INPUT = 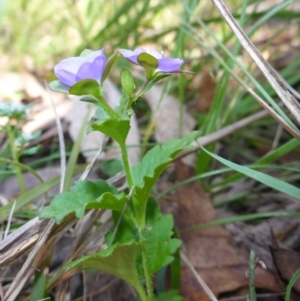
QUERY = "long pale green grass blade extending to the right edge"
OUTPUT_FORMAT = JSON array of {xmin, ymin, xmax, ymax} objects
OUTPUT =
[{"xmin": 201, "ymin": 146, "xmax": 300, "ymax": 200}]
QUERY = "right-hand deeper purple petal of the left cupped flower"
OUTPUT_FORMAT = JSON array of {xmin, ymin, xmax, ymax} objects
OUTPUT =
[{"xmin": 76, "ymin": 51, "xmax": 106, "ymax": 82}]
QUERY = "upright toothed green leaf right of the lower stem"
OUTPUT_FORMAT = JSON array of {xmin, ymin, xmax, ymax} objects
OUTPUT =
[{"xmin": 145, "ymin": 198, "xmax": 181, "ymax": 275}]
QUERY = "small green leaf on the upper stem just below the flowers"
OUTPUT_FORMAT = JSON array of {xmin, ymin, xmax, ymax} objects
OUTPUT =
[{"xmin": 90, "ymin": 107, "xmax": 130, "ymax": 145}]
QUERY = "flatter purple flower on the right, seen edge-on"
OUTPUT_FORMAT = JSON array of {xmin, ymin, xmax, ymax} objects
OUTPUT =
[{"xmin": 119, "ymin": 48, "xmax": 184, "ymax": 73}]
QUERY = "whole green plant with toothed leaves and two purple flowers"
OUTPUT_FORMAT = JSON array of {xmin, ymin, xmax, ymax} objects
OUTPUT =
[{"xmin": 41, "ymin": 48, "xmax": 197, "ymax": 301}]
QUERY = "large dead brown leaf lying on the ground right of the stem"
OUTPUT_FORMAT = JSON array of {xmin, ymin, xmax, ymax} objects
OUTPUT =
[{"xmin": 166, "ymin": 162, "xmax": 282, "ymax": 301}]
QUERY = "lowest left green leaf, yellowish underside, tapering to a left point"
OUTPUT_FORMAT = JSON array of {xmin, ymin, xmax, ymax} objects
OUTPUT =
[{"xmin": 65, "ymin": 242, "xmax": 144, "ymax": 294}]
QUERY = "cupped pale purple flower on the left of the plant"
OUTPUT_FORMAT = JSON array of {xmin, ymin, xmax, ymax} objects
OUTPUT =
[{"xmin": 54, "ymin": 49, "xmax": 106, "ymax": 87}]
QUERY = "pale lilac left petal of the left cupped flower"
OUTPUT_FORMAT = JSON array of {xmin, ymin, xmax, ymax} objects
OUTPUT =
[{"xmin": 54, "ymin": 57, "xmax": 85, "ymax": 87}]
